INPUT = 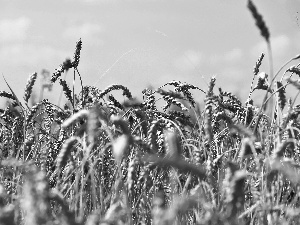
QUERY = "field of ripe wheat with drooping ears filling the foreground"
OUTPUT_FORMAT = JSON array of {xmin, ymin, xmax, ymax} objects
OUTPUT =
[{"xmin": 0, "ymin": 0, "xmax": 300, "ymax": 225}]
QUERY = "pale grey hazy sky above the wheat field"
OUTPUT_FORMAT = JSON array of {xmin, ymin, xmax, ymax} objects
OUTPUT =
[{"xmin": 0, "ymin": 0, "xmax": 300, "ymax": 107}]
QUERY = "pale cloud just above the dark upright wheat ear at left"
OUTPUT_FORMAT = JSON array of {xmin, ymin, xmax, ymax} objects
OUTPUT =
[{"xmin": 63, "ymin": 23, "xmax": 103, "ymax": 46}]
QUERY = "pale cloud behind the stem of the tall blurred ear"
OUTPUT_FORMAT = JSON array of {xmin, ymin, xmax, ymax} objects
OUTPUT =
[{"xmin": 251, "ymin": 35, "xmax": 291, "ymax": 57}]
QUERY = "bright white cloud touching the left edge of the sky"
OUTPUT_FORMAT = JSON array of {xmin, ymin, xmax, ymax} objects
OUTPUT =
[{"xmin": 0, "ymin": 17, "xmax": 31, "ymax": 42}]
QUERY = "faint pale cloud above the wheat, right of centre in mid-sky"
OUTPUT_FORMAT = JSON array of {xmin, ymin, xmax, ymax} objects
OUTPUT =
[{"xmin": 174, "ymin": 50, "xmax": 204, "ymax": 72}]
